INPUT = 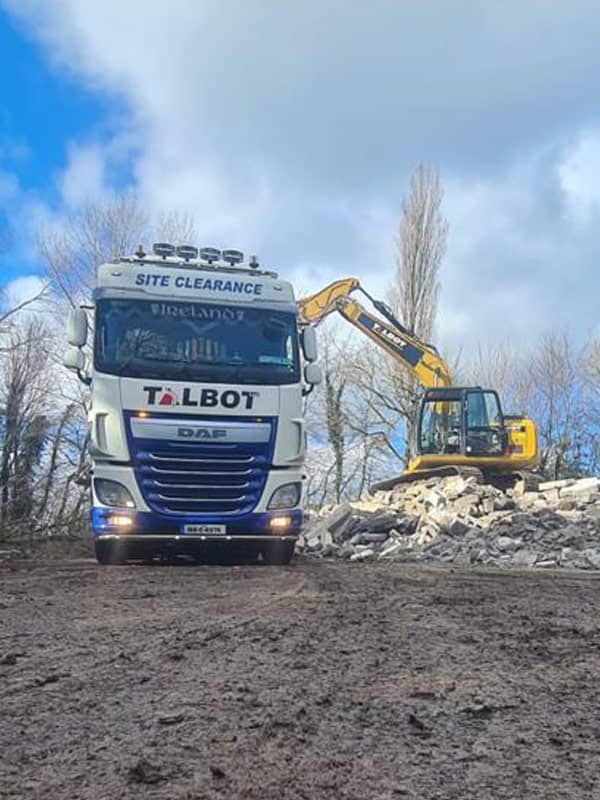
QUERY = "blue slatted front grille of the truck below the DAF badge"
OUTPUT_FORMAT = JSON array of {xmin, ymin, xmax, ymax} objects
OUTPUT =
[{"xmin": 129, "ymin": 416, "xmax": 274, "ymax": 516}]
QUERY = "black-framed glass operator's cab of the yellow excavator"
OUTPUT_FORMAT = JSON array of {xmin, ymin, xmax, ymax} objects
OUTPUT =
[{"xmin": 417, "ymin": 386, "xmax": 508, "ymax": 460}]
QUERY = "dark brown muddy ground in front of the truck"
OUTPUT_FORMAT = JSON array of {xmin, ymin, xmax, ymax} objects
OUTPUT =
[{"xmin": 0, "ymin": 559, "xmax": 600, "ymax": 800}]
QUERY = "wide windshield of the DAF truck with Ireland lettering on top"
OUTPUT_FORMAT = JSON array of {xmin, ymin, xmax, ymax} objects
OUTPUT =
[{"xmin": 94, "ymin": 299, "xmax": 300, "ymax": 384}]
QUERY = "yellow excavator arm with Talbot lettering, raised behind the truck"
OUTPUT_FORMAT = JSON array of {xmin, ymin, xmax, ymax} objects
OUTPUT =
[{"xmin": 298, "ymin": 278, "xmax": 452, "ymax": 388}]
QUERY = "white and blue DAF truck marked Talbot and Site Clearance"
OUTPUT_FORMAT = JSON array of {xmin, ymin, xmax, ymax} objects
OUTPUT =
[{"xmin": 64, "ymin": 242, "xmax": 321, "ymax": 564}]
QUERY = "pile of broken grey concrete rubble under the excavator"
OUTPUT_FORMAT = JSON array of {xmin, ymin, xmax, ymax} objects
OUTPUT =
[{"xmin": 299, "ymin": 475, "xmax": 600, "ymax": 569}]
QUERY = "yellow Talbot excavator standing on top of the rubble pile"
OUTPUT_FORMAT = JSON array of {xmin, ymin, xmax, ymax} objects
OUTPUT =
[{"xmin": 298, "ymin": 278, "xmax": 538, "ymax": 491}]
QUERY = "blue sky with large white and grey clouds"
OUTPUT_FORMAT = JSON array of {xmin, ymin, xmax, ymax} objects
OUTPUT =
[{"xmin": 0, "ymin": 0, "xmax": 600, "ymax": 351}]
